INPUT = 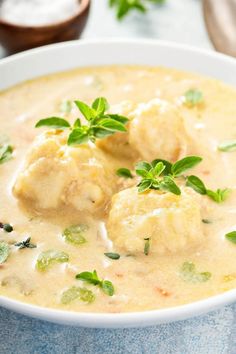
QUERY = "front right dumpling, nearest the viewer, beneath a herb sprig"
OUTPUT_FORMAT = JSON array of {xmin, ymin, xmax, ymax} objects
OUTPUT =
[{"xmin": 107, "ymin": 187, "xmax": 204, "ymax": 254}]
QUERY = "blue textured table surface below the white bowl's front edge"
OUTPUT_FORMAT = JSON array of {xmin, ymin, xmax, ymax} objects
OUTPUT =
[{"xmin": 0, "ymin": 305, "xmax": 236, "ymax": 354}]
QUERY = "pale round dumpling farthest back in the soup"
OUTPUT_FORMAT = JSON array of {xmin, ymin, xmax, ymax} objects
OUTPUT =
[{"xmin": 129, "ymin": 98, "xmax": 187, "ymax": 161}]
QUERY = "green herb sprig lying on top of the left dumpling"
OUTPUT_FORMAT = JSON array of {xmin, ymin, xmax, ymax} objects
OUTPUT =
[{"xmin": 35, "ymin": 97, "xmax": 128, "ymax": 145}]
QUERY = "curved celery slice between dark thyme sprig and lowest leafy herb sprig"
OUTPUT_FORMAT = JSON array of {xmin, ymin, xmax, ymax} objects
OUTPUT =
[{"xmin": 36, "ymin": 250, "xmax": 69, "ymax": 271}]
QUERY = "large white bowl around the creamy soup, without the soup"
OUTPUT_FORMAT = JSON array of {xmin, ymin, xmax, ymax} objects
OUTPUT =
[{"xmin": 0, "ymin": 39, "xmax": 236, "ymax": 328}]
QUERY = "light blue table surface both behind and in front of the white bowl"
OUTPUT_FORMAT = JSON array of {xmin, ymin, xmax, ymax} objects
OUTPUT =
[{"xmin": 0, "ymin": 0, "xmax": 236, "ymax": 354}]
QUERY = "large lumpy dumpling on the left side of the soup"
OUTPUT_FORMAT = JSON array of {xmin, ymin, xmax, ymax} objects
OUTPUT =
[{"xmin": 13, "ymin": 131, "xmax": 116, "ymax": 213}]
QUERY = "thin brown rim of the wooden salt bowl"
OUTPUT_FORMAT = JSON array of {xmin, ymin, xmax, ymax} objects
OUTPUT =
[{"xmin": 0, "ymin": 0, "xmax": 91, "ymax": 32}]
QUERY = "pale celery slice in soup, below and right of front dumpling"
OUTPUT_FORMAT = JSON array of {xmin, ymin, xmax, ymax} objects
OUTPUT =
[{"xmin": 180, "ymin": 262, "xmax": 211, "ymax": 283}]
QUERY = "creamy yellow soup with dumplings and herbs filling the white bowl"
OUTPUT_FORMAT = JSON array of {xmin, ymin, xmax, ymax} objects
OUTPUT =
[{"xmin": 0, "ymin": 66, "xmax": 236, "ymax": 313}]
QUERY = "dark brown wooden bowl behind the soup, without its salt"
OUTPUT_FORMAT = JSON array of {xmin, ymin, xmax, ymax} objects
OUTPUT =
[{"xmin": 0, "ymin": 0, "xmax": 91, "ymax": 54}]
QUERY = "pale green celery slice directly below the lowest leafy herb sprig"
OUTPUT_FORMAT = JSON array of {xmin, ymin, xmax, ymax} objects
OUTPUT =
[{"xmin": 61, "ymin": 286, "xmax": 95, "ymax": 305}]
